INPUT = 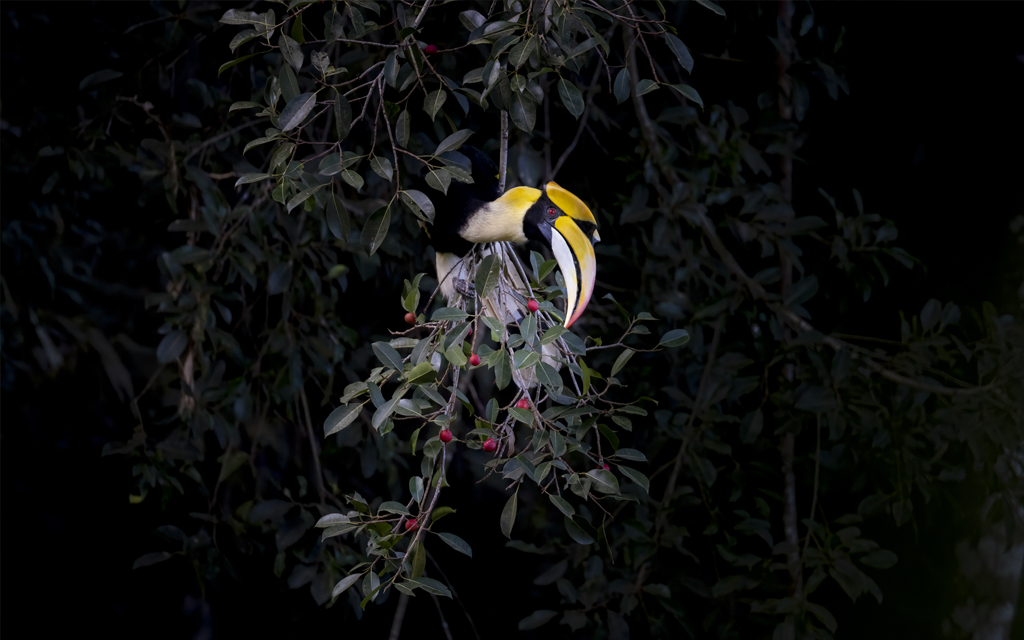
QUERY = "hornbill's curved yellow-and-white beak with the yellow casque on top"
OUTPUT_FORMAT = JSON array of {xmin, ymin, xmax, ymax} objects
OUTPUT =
[{"xmin": 545, "ymin": 182, "xmax": 601, "ymax": 329}]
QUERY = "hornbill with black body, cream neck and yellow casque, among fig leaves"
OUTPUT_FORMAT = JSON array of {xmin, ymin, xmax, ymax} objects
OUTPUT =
[{"xmin": 427, "ymin": 145, "xmax": 600, "ymax": 328}]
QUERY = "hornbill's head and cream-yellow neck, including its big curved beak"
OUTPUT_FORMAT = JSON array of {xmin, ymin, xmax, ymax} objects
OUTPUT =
[{"xmin": 446, "ymin": 182, "xmax": 600, "ymax": 327}]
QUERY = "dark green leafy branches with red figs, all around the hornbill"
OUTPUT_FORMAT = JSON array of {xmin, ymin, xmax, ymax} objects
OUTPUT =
[{"xmin": 2, "ymin": 0, "xmax": 1024, "ymax": 638}]
